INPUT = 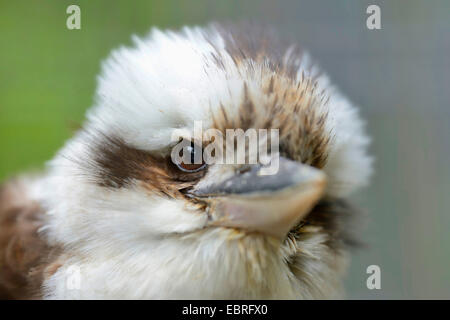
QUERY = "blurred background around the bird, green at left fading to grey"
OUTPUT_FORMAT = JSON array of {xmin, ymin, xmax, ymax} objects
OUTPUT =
[{"xmin": 0, "ymin": 0, "xmax": 450, "ymax": 299}]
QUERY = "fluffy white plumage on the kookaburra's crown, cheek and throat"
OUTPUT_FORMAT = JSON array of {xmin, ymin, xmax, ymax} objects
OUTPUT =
[{"xmin": 23, "ymin": 27, "xmax": 371, "ymax": 299}]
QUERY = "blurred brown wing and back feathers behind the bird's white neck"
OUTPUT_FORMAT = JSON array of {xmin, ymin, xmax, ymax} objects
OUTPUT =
[{"xmin": 0, "ymin": 180, "xmax": 59, "ymax": 299}]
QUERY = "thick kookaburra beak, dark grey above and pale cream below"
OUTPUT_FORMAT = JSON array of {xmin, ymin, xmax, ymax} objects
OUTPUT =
[{"xmin": 190, "ymin": 157, "xmax": 326, "ymax": 239}]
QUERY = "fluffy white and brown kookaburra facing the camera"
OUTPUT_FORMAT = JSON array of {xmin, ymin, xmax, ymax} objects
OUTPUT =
[{"xmin": 0, "ymin": 25, "xmax": 371, "ymax": 299}]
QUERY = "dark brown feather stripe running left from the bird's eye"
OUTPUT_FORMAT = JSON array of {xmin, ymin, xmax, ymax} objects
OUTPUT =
[{"xmin": 74, "ymin": 132, "xmax": 204, "ymax": 197}]
